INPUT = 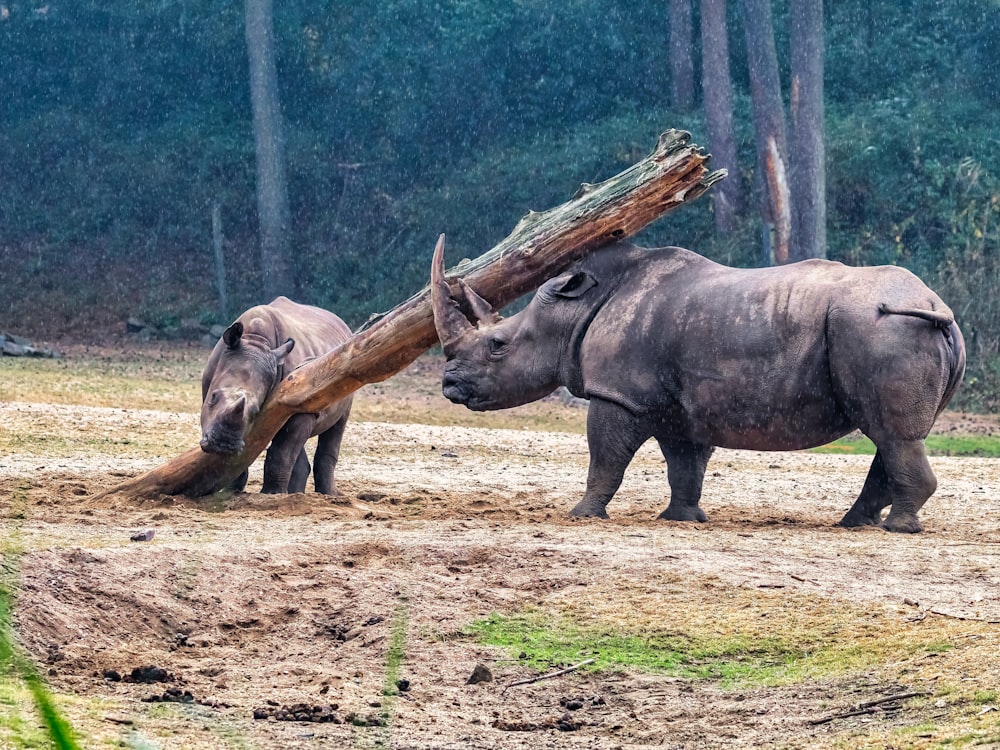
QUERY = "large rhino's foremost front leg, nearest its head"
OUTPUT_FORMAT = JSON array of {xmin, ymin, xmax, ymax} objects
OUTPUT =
[{"xmin": 569, "ymin": 398, "xmax": 650, "ymax": 518}]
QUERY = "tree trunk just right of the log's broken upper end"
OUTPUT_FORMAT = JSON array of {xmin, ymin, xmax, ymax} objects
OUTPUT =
[{"xmin": 701, "ymin": 0, "xmax": 743, "ymax": 234}]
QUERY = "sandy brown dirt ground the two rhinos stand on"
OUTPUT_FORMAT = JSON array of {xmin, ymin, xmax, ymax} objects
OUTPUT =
[{"xmin": 0, "ymin": 354, "xmax": 1000, "ymax": 750}]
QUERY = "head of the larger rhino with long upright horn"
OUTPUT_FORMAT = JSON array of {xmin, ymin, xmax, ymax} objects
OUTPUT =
[{"xmin": 431, "ymin": 235, "xmax": 596, "ymax": 411}]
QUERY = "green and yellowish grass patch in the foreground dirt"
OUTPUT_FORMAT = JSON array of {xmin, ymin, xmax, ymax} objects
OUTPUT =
[{"xmin": 466, "ymin": 589, "xmax": 968, "ymax": 688}]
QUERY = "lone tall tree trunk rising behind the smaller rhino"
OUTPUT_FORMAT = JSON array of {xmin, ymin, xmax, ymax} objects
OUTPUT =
[{"xmin": 246, "ymin": 0, "xmax": 294, "ymax": 300}]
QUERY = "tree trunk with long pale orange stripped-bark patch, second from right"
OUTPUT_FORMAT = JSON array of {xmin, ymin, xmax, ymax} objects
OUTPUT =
[{"xmin": 742, "ymin": 0, "xmax": 792, "ymax": 263}]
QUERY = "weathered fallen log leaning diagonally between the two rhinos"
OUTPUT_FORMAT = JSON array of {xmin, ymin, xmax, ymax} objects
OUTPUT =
[{"xmin": 104, "ymin": 130, "xmax": 726, "ymax": 497}]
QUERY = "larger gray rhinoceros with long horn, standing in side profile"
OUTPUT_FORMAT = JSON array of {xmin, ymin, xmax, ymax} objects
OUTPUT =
[{"xmin": 431, "ymin": 240, "xmax": 965, "ymax": 532}]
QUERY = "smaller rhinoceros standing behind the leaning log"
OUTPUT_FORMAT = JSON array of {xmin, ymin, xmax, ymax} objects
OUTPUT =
[{"xmin": 201, "ymin": 297, "xmax": 351, "ymax": 495}]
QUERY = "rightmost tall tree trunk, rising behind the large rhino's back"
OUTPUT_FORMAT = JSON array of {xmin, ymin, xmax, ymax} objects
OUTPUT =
[{"xmin": 790, "ymin": 0, "xmax": 826, "ymax": 260}]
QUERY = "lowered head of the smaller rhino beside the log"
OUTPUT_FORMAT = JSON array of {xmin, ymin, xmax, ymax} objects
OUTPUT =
[{"xmin": 201, "ymin": 321, "xmax": 295, "ymax": 454}]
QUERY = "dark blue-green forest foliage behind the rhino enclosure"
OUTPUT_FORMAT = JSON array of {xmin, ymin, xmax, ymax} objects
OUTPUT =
[{"xmin": 0, "ymin": 0, "xmax": 1000, "ymax": 411}]
